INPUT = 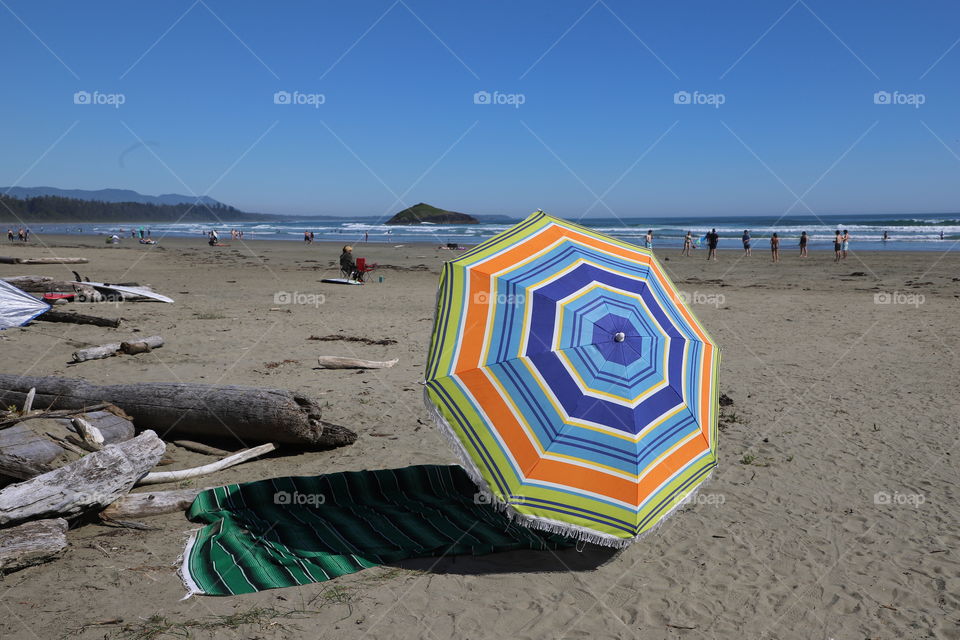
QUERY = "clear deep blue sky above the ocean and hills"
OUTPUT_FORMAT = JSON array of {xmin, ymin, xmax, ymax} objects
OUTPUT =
[{"xmin": 0, "ymin": 0, "xmax": 960, "ymax": 217}]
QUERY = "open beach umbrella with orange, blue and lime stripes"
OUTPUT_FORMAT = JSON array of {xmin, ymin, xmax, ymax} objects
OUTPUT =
[{"xmin": 425, "ymin": 211, "xmax": 720, "ymax": 546}]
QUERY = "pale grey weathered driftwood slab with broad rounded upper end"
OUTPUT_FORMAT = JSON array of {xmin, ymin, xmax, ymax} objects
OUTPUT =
[{"xmin": 0, "ymin": 430, "xmax": 166, "ymax": 527}]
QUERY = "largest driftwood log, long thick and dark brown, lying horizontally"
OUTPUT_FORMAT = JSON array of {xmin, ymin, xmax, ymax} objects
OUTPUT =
[{"xmin": 0, "ymin": 374, "xmax": 357, "ymax": 447}]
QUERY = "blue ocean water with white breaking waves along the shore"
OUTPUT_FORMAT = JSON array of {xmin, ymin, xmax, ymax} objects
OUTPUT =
[{"xmin": 35, "ymin": 213, "xmax": 960, "ymax": 251}]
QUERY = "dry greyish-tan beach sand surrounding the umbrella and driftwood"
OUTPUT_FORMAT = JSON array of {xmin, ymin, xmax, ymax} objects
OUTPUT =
[{"xmin": 0, "ymin": 237, "xmax": 960, "ymax": 640}]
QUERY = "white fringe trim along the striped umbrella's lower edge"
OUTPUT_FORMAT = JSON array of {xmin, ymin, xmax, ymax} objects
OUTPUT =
[{"xmin": 423, "ymin": 389, "xmax": 716, "ymax": 549}]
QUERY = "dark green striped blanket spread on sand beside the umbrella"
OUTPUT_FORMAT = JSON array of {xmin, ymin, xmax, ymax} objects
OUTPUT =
[{"xmin": 181, "ymin": 465, "xmax": 573, "ymax": 596}]
